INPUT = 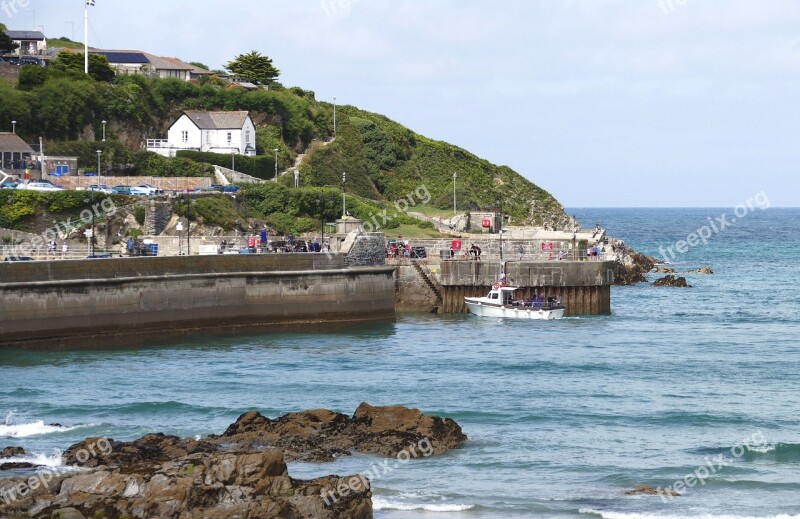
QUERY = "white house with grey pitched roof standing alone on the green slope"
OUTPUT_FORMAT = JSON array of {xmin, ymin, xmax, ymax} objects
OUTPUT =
[{"xmin": 147, "ymin": 111, "xmax": 256, "ymax": 157}]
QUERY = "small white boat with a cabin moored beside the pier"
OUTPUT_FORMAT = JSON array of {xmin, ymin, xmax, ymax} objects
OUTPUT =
[{"xmin": 464, "ymin": 286, "xmax": 564, "ymax": 320}]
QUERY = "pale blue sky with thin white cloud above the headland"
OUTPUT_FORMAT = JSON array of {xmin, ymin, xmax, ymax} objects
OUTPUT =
[{"xmin": 0, "ymin": 0, "xmax": 800, "ymax": 207}]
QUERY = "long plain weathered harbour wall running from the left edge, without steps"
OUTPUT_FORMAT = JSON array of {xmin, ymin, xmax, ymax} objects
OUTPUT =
[{"xmin": 0, "ymin": 254, "xmax": 395, "ymax": 349}]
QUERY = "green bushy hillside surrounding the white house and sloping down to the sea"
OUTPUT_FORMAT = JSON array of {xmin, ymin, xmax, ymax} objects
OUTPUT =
[{"xmin": 0, "ymin": 58, "xmax": 565, "ymax": 223}]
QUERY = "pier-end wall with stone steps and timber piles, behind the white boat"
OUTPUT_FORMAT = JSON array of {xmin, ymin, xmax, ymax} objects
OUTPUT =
[{"xmin": 395, "ymin": 260, "xmax": 614, "ymax": 316}]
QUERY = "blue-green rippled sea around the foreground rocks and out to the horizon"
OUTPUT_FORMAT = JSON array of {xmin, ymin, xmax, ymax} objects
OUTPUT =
[{"xmin": 0, "ymin": 208, "xmax": 800, "ymax": 519}]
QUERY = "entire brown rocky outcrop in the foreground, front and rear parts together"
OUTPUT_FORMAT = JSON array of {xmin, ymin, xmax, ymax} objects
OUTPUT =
[{"xmin": 0, "ymin": 404, "xmax": 467, "ymax": 519}]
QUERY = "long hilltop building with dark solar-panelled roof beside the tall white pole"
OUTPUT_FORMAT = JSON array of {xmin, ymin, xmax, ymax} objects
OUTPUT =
[{"xmin": 90, "ymin": 50, "xmax": 213, "ymax": 81}]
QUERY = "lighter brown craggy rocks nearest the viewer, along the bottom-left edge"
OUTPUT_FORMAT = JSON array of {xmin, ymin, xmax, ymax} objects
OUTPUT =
[{"xmin": 0, "ymin": 444, "xmax": 372, "ymax": 519}]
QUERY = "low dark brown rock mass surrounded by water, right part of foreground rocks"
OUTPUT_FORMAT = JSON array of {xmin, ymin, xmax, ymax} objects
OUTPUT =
[{"xmin": 219, "ymin": 403, "xmax": 467, "ymax": 461}]
